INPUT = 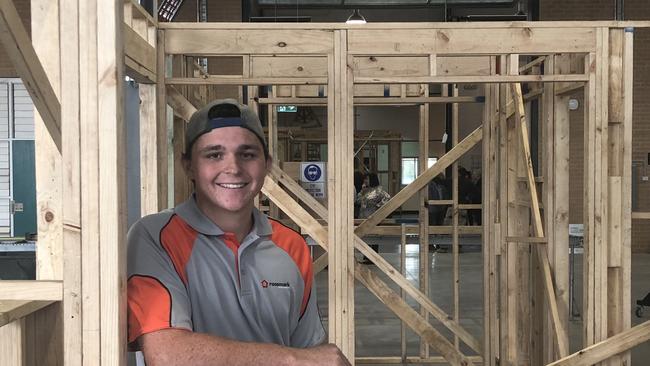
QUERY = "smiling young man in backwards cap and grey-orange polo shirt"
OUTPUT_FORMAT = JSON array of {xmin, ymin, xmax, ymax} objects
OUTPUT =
[{"xmin": 128, "ymin": 99, "xmax": 349, "ymax": 366}]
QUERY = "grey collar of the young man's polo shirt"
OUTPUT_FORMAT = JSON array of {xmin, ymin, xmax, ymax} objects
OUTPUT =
[{"xmin": 174, "ymin": 195, "xmax": 273, "ymax": 236}]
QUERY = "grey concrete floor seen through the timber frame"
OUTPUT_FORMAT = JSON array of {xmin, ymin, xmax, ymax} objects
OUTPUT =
[{"xmin": 316, "ymin": 237, "xmax": 650, "ymax": 365}]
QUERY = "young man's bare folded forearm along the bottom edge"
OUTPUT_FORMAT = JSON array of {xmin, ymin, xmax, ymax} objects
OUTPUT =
[{"xmin": 139, "ymin": 329, "xmax": 350, "ymax": 366}]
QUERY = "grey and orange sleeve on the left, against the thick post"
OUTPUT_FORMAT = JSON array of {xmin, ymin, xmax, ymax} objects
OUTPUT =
[{"xmin": 127, "ymin": 214, "xmax": 193, "ymax": 350}]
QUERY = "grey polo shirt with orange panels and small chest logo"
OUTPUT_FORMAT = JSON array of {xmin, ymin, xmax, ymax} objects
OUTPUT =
[{"xmin": 127, "ymin": 197, "xmax": 325, "ymax": 349}]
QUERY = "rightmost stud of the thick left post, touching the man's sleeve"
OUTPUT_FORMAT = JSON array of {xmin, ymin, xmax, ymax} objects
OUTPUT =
[{"xmin": 97, "ymin": 1, "xmax": 126, "ymax": 365}]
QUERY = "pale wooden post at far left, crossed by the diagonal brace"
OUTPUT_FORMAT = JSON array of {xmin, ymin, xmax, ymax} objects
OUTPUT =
[{"xmin": 30, "ymin": 0, "xmax": 63, "ymax": 365}]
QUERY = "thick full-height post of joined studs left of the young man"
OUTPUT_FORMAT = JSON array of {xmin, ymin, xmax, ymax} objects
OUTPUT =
[{"xmin": 60, "ymin": 1, "xmax": 126, "ymax": 365}]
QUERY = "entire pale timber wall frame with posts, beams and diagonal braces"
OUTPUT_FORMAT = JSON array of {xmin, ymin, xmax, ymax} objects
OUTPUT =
[{"xmin": 0, "ymin": 0, "xmax": 650, "ymax": 365}]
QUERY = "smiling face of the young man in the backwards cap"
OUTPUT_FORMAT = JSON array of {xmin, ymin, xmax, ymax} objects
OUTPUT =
[{"xmin": 185, "ymin": 127, "xmax": 271, "ymax": 218}]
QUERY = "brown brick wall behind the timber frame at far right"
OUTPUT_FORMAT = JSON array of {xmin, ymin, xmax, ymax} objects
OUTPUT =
[{"xmin": 540, "ymin": 0, "xmax": 650, "ymax": 252}]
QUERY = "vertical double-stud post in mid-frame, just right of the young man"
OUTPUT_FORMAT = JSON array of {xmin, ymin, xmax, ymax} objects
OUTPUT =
[{"xmin": 328, "ymin": 30, "xmax": 354, "ymax": 362}]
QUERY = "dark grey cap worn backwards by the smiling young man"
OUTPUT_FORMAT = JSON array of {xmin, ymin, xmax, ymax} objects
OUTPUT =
[{"xmin": 185, "ymin": 99, "xmax": 268, "ymax": 157}]
